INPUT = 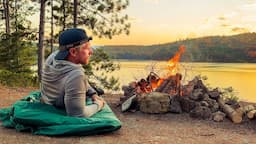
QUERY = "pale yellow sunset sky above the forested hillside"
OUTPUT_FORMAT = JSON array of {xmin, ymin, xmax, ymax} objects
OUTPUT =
[{"xmin": 93, "ymin": 0, "xmax": 256, "ymax": 45}]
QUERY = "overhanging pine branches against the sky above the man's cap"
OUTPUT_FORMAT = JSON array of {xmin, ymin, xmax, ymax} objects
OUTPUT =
[{"xmin": 49, "ymin": 0, "xmax": 131, "ymax": 39}]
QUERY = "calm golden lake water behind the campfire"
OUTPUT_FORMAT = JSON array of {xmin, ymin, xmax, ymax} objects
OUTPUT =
[{"xmin": 106, "ymin": 60, "xmax": 256, "ymax": 102}]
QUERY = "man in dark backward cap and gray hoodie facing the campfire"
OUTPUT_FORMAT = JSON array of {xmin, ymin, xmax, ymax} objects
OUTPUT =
[{"xmin": 41, "ymin": 28, "xmax": 104, "ymax": 117}]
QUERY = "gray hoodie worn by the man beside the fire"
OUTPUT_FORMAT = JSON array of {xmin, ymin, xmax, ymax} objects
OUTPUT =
[{"xmin": 41, "ymin": 51, "xmax": 99, "ymax": 117}]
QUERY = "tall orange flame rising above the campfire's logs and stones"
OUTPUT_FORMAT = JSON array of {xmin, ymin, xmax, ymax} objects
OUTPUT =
[{"xmin": 167, "ymin": 45, "xmax": 186, "ymax": 76}]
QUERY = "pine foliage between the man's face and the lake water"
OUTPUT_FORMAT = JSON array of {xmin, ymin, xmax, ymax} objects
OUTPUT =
[{"xmin": 83, "ymin": 48, "xmax": 120, "ymax": 91}]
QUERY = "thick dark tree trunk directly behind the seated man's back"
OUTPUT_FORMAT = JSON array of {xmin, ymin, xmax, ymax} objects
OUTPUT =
[{"xmin": 38, "ymin": 0, "xmax": 45, "ymax": 82}]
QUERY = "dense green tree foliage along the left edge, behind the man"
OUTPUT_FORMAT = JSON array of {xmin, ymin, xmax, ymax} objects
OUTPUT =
[{"xmin": 0, "ymin": 0, "xmax": 37, "ymax": 86}]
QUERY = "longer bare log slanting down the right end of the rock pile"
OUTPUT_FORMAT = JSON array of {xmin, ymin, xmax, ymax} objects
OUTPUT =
[{"xmin": 218, "ymin": 98, "xmax": 242, "ymax": 123}]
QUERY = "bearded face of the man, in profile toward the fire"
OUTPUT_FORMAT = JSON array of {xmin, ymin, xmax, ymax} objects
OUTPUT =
[{"xmin": 77, "ymin": 42, "xmax": 93, "ymax": 64}]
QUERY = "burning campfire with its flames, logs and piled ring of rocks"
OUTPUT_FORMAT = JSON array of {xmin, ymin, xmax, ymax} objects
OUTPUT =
[{"xmin": 120, "ymin": 45, "xmax": 256, "ymax": 123}]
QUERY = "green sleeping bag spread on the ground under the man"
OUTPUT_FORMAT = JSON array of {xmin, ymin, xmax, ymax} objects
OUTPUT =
[{"xmin": 0, "ymin": 92, "xmax": 121, "ymax": 136}]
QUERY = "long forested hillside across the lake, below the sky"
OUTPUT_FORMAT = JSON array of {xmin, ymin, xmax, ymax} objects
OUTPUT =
[{"xmin": 103, "ymin": 33, "xmax": 256, "ymax": 62}]
